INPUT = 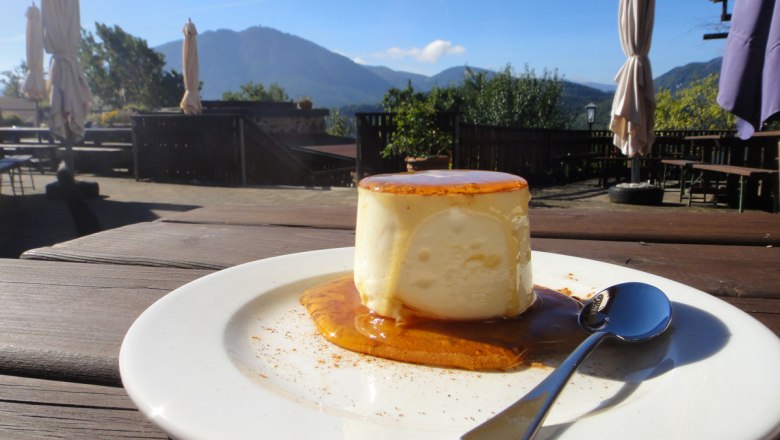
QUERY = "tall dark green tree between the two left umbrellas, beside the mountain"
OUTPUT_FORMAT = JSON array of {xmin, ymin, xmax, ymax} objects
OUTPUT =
[{"xmin": 79, "ymin": 23, "xmax": 184, "ymax": 108}]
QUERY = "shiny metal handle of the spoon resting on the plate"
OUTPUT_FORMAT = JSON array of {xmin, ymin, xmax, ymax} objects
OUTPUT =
[{"xmin": 461, "ymin": 332, "xmax": 611, "ymax": 440}]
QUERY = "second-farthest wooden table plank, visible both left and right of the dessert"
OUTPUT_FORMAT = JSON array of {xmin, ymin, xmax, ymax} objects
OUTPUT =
[{"xmin": 18, "ymin": 222, "xmax": 780, "ymax": 298}]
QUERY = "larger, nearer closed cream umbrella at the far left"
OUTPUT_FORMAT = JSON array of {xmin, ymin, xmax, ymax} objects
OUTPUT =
[{"xmin": 41, "ymin": 0, "xmax": 92, "ymax": 170}]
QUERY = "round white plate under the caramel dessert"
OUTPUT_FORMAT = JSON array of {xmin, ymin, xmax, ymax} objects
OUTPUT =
[{"xmin": 119, "ymin": 248, "xmax": 780, "ymax": 440}]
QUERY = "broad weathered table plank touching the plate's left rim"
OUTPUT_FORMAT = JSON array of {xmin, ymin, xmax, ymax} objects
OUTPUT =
[{"xmin": 0, "ymin": 259, "xmax": 211, "ymax": 386}]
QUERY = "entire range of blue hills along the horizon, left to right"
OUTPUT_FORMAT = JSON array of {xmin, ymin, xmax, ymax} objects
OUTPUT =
[{"xmin": 154, "ymin": 26, "xmax": 720, "ymax": 115}]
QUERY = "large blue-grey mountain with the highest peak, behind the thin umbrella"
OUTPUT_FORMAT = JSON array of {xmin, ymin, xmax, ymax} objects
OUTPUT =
[{"xmin": 154, "ymin": 26, "xmax": 388, "ymax": 106}]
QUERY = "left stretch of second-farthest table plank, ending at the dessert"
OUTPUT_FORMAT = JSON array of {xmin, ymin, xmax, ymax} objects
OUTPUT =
[{"xmin": 22, "ymin": 222, "xmax": 355, "ymax": 269}]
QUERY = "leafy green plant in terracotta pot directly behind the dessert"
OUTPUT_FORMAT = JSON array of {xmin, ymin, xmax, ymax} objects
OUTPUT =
[{"xmin": 381, "ymin": 93, "xmax": 452, "ymax": 171}]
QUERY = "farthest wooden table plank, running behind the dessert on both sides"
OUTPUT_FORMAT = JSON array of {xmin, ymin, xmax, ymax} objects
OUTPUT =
[{"xmin": 155, "ymin": 203, "xmax": 780, "ymax": 246}]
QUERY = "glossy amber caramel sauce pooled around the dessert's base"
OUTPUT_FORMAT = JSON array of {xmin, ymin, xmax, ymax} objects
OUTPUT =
[{"xmin": 300, "ymin": 275, "xmax": 587, "ymax": 370}]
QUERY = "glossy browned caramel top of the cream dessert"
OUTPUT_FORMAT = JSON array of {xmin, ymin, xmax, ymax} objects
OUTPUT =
[{"xmin": 358, "ymin": 170, "xmax": 528, "ymax": 196}]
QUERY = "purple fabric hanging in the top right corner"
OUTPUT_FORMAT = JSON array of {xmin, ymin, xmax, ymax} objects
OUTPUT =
[{"xmin": 718, "ymin": 0, "xmax": 780, "ymax": 139}]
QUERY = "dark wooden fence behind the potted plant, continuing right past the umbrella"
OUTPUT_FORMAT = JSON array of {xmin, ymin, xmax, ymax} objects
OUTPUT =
[{"xmin": 356, "ymin": 113, "xmax": 727, "ymax": 183}]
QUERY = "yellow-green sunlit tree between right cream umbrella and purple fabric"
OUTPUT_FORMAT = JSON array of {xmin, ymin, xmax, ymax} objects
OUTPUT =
[{"xmin": 655, "ymin": 74, "xmax": 736, "ymax": 130}]
